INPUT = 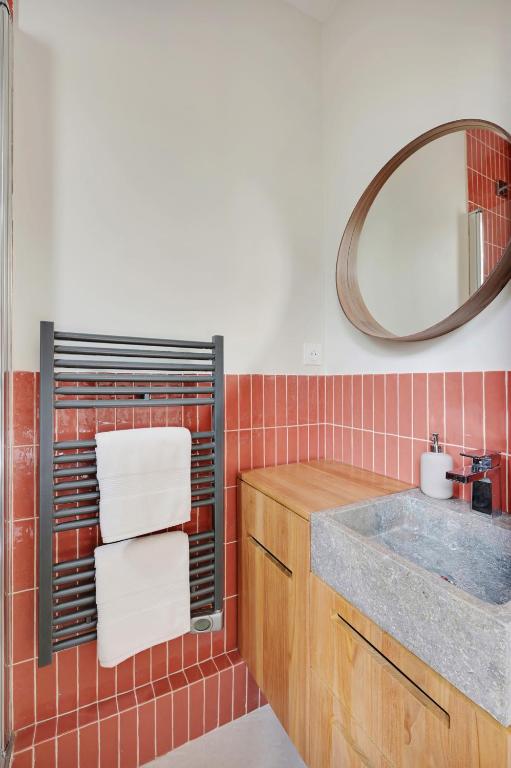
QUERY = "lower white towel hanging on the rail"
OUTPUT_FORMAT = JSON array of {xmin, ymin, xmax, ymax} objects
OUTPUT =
[{"xmin": 94, "ymin": 531, "xmax": 190, "ymax": 667}]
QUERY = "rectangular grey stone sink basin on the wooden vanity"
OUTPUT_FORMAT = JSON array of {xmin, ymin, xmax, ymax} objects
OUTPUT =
[{"xmin": 312, "ymin": 490, "xmax": 511, "ymax": 726}]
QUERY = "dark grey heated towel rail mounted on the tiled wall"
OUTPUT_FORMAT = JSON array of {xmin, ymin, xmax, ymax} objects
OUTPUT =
[{"xmin": 38, "ymin": 322, "xmax": 224, "ymax": 666}]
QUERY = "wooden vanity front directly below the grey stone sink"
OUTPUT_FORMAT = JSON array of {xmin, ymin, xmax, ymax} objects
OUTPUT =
[{"xmin": 309, "ymin": 575, "xmax": 511, "ymax": 768}]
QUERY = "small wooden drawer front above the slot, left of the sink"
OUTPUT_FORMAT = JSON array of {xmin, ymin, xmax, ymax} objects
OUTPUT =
[{"xmin": 240, "ymin": 482, "xmax": 309, "ymax": 572}]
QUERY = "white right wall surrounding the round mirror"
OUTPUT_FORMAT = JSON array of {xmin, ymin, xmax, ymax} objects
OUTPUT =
[{"xmin": 323, "ymin": 0, "xmax": 511, "ymax": 373}]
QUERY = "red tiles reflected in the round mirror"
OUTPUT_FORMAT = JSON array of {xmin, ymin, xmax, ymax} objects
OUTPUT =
[{"xmin": 467, "ymin": 130, "xmax": 511, "ymax": 277}]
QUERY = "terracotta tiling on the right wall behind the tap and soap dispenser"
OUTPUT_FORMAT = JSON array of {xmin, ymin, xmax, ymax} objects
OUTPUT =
[{"xmin": 325, "ymin": 371, "xmax": 511, "ymax": 511}]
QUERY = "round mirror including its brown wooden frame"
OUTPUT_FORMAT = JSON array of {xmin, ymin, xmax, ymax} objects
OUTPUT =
[{"xmin": 337, "ymin": 120, "xmax": 511, "ymax": 341}]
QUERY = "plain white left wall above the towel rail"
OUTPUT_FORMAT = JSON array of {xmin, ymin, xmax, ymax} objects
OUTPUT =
[{"xmin": 14, "ymin": 0, "xmax": 323, "ymax": 372}]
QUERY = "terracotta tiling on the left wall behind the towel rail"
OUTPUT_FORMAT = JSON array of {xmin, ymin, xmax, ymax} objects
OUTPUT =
[{"xmin": 7, "ymin": 372, "xmax": 324, "ymax": 768}]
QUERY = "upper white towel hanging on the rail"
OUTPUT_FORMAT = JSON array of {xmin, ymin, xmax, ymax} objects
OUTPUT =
[{"xmin": 96, "ymin": 427, "xmax": 191, "ymax": 543}]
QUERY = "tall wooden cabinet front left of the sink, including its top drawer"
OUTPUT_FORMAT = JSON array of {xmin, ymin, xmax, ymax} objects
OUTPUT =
[{"xmin": 238, "ymin": 483, "xmax": 309, "ymax": 760}]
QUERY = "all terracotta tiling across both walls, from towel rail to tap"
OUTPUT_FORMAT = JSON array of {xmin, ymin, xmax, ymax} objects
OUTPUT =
[{"xmin": 8, "ymin": 371, "xmax": 511, "ymax": 768}]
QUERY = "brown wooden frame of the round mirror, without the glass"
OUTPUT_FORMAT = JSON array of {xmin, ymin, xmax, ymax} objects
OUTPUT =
[{"xmin": 336, "ymin": 120, "xmax": 511, "ymax": 341}]
